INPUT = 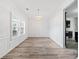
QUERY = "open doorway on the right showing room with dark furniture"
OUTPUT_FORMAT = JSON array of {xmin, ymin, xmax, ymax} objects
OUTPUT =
[{"xmin": 65, "ymin": 0, "xmax": 78, "ymax": 50}]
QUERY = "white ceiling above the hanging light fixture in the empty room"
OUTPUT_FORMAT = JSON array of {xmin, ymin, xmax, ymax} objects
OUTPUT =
[{"xmin": 12, "ymin": 0, "xmax": 64, "ymax": 16}]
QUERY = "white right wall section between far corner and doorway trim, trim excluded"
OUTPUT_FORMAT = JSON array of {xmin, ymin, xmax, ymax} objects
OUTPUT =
[{"xmin": 50, "ymin": 10, "xmax": 63, "ymax": 47}]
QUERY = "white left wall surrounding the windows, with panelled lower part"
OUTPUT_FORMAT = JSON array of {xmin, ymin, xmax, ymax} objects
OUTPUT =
[{"xmin": 0, "ymin": 0, "xmax": 28, "ymax": 58}]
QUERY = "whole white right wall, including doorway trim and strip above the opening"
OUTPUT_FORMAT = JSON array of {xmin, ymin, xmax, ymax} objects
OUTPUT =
[{"xmin": 50, "ymin": 0, "xmax": 73, "ymax": 47}]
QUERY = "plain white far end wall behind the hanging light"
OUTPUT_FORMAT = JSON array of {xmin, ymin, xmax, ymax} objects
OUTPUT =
[{"xmin": 29, "ymin": 16, "xmax": 49, "ymax": 37}]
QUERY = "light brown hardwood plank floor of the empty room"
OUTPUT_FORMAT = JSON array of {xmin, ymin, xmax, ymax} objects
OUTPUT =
[{"xmin": 1, "ymin": 38, "xmax": 77, "ymax": 59}]
